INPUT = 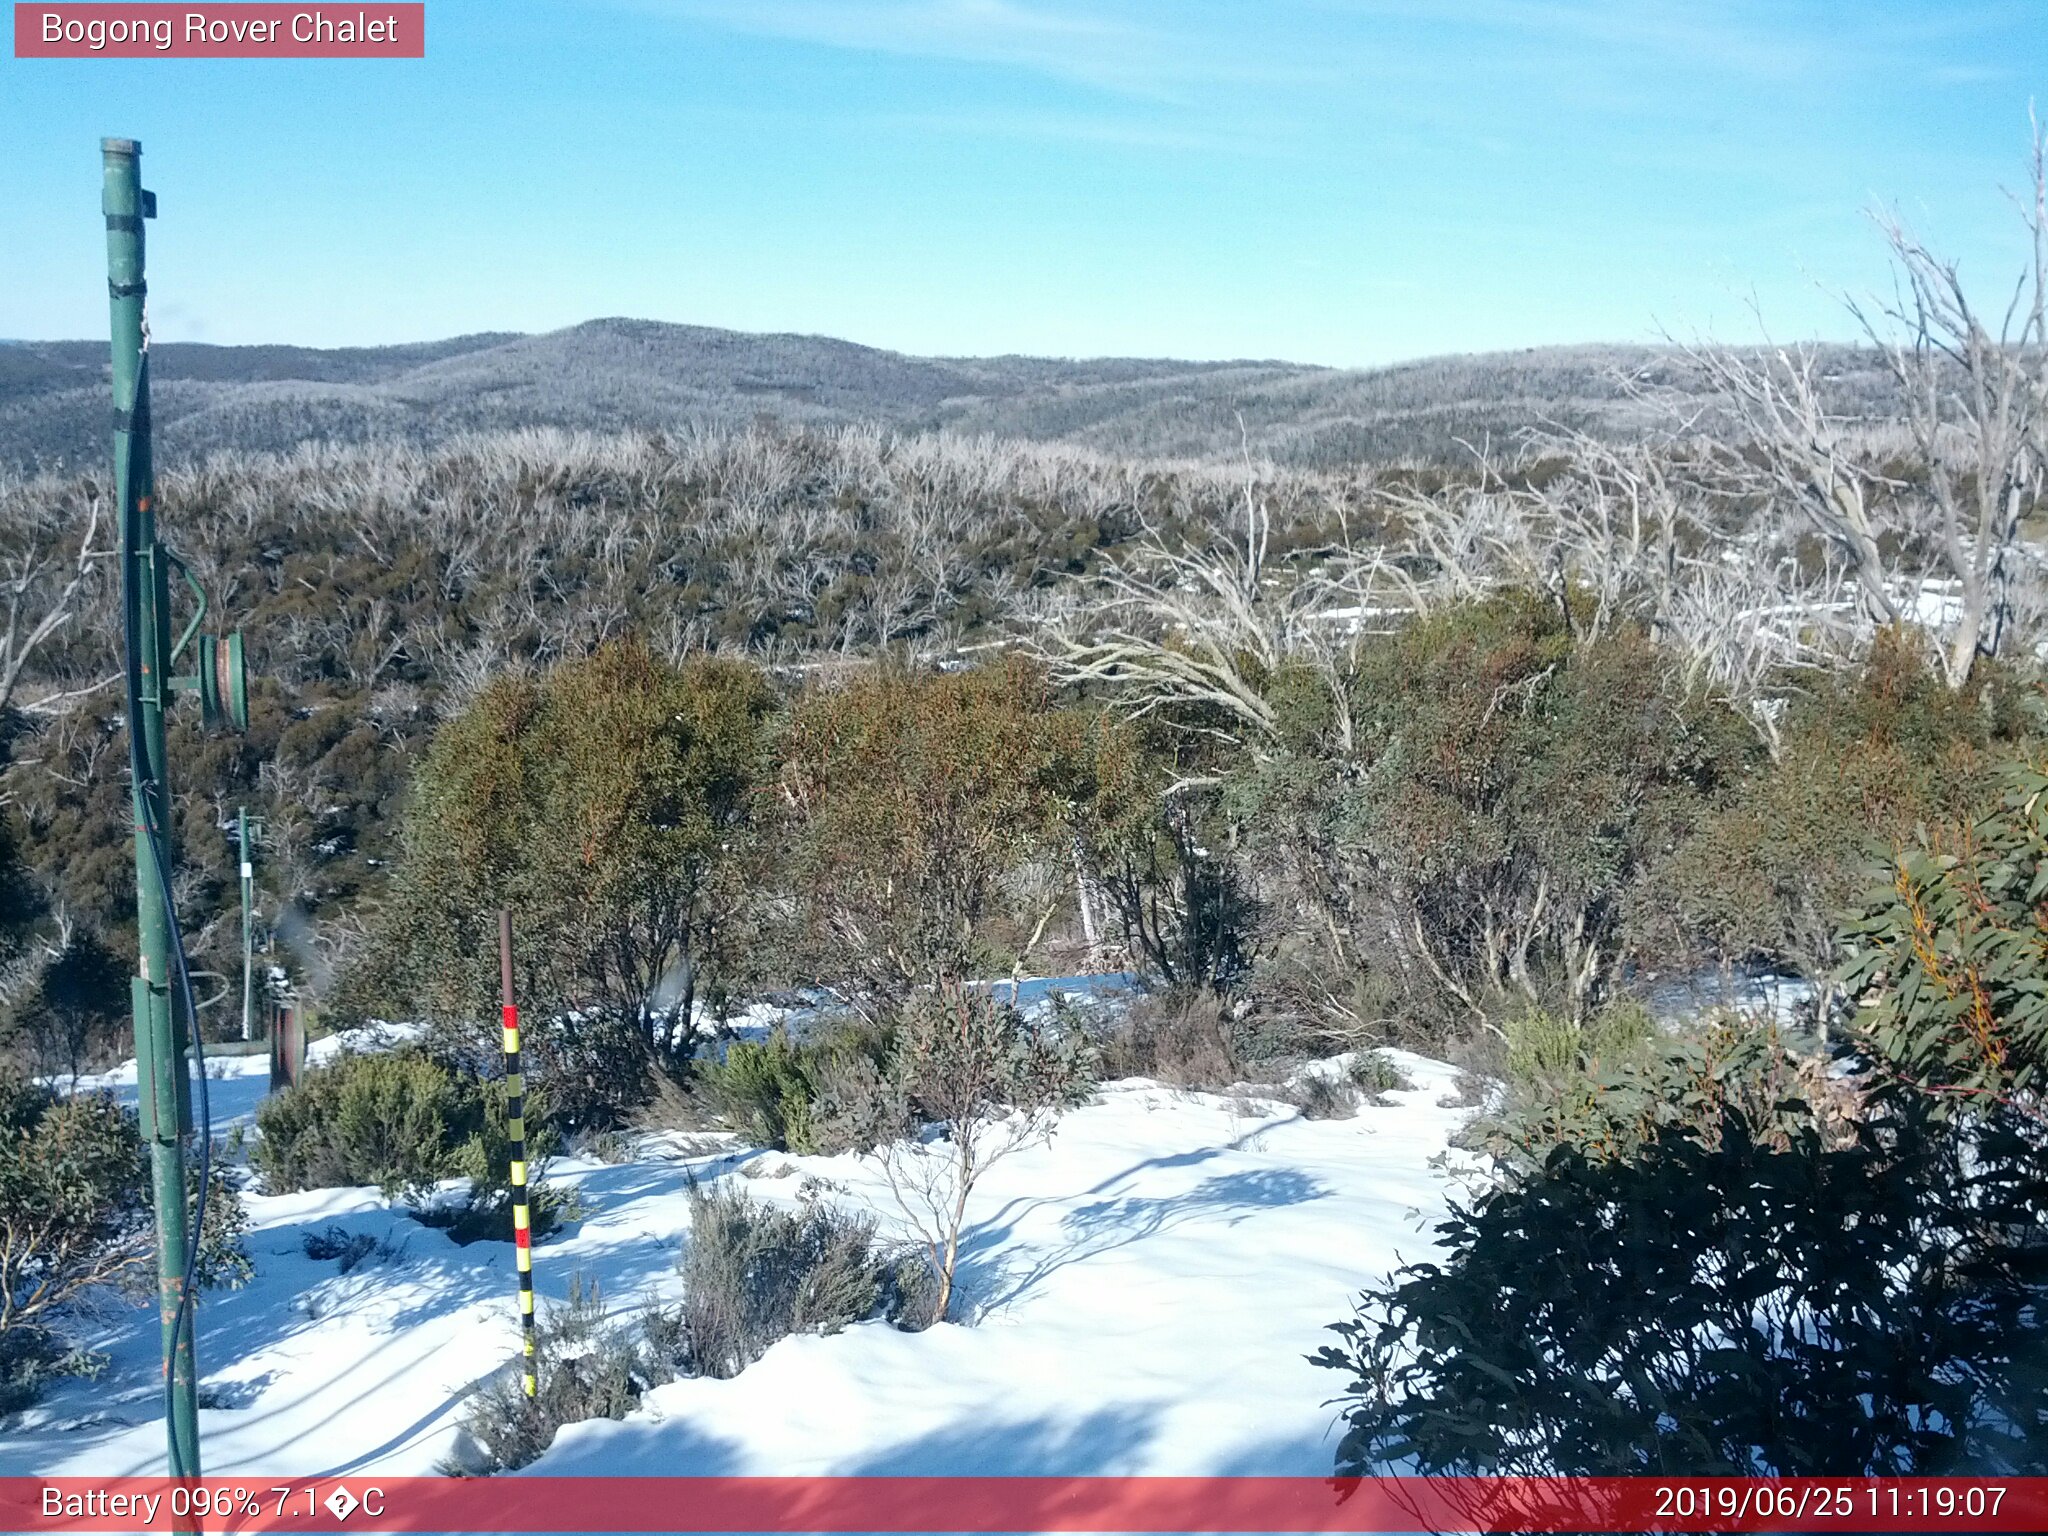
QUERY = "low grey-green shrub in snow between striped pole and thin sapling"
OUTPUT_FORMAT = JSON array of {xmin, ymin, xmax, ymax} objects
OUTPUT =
[{"xmin": 682, "ymin": 1184, "xmax": 887, "ymax": 1376}]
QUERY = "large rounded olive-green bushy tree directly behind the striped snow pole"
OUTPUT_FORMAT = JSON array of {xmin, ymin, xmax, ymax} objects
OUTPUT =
[{"xmin": 352, "ymin": 639, "xmax": 774, "ymax": 1126}]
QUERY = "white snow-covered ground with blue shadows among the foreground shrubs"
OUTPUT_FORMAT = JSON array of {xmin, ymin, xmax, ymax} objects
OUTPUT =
[{"xmin": 0, "ymin": 1053, "xmax": 1470, "ymax": 1477}]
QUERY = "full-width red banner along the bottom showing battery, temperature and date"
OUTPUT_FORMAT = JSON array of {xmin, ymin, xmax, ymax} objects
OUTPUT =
[{"xmin": 0, "ymin": 1475, "xmax": 2048, "ymax": 1536}]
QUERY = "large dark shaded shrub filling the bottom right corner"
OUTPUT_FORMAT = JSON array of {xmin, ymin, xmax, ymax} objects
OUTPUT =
[{"xmin": 1319, "ymin": 768, "xmax": 2048, "ymax": 1475}]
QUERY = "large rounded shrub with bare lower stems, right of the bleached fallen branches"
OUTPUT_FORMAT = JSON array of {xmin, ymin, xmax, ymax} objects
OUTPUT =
[{"xmin": 1227, "ymin": 592, "xmax": 1759, "ymax": 1038}]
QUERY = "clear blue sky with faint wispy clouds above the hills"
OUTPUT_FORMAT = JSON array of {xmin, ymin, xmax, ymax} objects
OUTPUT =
[{"xmin": 0, "ymin": 0, "xmax": 2048, "ymax": 365}]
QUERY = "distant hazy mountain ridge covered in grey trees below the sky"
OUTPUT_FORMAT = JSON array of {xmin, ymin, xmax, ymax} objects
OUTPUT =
[{"xmin": 0, "ymin": 319, "xmax": 1892, "ymax": 467}]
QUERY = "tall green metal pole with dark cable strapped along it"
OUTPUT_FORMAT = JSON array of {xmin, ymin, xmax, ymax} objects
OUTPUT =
[{"xmin": 100, "ymin": 139, "xmax": 199, "ymax": 1499}]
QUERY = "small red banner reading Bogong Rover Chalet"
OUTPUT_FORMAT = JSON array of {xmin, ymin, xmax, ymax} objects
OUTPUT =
[{"xmin": 14, "ymin": 2, "xmax": 426, "ymax": 59}]
